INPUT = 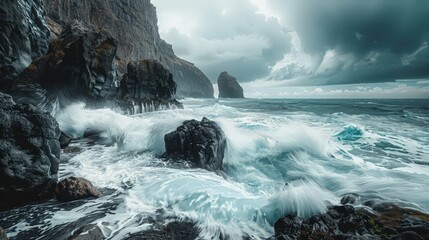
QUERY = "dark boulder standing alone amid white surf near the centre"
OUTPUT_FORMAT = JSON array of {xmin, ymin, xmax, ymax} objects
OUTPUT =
[{"xmin": 164, "ymin": 118, "xmax": 226, "ymax": 171}]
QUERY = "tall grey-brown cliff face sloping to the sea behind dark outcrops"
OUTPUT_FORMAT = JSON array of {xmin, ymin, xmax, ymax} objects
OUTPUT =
[{"xmin": 44, "ymin": 0, "xmax": 213, "ymax": 97}]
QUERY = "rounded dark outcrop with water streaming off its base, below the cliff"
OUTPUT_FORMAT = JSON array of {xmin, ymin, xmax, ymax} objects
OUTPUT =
[{"xmin": 120, "ymin": 59, "xmax": 183, "ymax": 114}]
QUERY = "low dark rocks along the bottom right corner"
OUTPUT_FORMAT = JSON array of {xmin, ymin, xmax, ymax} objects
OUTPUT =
[{"xmin": 272, "ymin": 203, "xmax": 429, "ymax": 240}]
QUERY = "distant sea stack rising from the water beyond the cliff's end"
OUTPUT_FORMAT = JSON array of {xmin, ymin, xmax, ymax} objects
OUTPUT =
[{"xmin": 217, "ymin": 72, "xmax": 244, "ymax": 98}]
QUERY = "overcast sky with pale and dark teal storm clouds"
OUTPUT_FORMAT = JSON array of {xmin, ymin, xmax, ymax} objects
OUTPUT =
[{"xmin": 152, "ymin": 0, "xmax": 429, "ymax": 97}]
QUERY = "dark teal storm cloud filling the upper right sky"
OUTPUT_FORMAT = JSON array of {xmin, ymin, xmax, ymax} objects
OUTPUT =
[{"xmin": 270, "ymin": 0, "xmax": 429, "ymax": 84}]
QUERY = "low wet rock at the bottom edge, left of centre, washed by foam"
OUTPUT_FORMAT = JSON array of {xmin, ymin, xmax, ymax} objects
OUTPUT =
[{"xmin": 125, "ymin": 221, "xmax": 200, "ymax": 240}]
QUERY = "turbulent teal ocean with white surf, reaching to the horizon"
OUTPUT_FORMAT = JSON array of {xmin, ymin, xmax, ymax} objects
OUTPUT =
[{"xmin": 0, "ymin": 99, "xmax": 429, "ymax": 240}]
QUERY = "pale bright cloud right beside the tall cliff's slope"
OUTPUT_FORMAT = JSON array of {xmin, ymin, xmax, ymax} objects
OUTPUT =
[{"xmin": 153, "ymin": 0, "xmax": 290, "ymax": 82}]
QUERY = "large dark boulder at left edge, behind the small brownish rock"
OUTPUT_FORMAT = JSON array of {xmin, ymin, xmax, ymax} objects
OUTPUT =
[{"xmin": 0, "ymin": 92, "xmax": 61, "ymax": 209}]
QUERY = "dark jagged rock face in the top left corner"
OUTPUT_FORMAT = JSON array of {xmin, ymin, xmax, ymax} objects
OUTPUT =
[{"xmin": 0, "ymin": 0, "xmax": 50, "ymax": 82}]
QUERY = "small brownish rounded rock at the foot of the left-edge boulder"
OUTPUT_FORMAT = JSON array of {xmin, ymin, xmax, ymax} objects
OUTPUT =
[{"xmin": 55, "ymin": 177, "xmax": 103, "ymax": 202}]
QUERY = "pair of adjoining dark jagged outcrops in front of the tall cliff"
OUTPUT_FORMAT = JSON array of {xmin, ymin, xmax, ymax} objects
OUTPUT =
[{"xmin": 5, "ymin": 21, "xmax": 183, "ymax": 114}]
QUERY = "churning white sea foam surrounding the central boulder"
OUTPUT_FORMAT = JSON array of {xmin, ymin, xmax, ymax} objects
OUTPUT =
[{"xmin": 41, "ymin": 99, "xmax": 429, "ymax": 239}]
